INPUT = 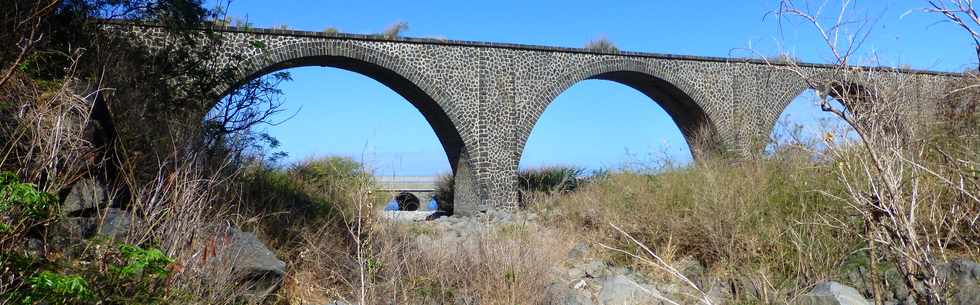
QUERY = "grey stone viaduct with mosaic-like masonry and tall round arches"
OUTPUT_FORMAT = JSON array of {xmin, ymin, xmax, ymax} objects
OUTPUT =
[{"xmin": 103, "ymin": 21, "xmax": 957, "ymax": 214}]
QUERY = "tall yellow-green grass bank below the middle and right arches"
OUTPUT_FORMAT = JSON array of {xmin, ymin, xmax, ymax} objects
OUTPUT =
[{"xmin": 532, "ymin": 154, "xmax": 861, "ymax": 300}]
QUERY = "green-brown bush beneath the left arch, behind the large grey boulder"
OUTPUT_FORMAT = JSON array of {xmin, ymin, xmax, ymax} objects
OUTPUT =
[{"xmin": 235, "ymin": 157, "xmax": 380, "ymax": 262}]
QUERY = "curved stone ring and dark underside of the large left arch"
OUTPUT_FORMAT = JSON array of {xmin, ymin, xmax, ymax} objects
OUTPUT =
[{"xmin": 218, "ymin": 42, "xmax": 469, "ymax": 173}]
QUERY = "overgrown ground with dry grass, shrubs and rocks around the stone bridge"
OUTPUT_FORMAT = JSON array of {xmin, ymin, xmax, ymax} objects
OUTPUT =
[{"xmin": 0, "ymin": 0, "xmax": 980, "ymax": 305}]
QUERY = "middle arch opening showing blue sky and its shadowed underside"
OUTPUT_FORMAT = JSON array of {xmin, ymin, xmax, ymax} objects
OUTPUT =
[{"xmin": 519, "ymin": 71, "xmax": 703, "ymax": 175}]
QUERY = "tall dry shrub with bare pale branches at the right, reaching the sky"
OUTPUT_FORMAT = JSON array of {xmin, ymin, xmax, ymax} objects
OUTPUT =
[{"xmin": 776, "ymin": 0, "xmax": 980, "ymax": 304}]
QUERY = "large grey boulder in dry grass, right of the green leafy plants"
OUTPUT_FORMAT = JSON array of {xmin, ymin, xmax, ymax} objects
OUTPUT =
[{"xmin": 217, "ymin": 228, "xmax": 286, "ymax": 298}]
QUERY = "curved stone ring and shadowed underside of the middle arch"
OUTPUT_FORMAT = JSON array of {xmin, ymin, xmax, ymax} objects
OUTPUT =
[{"xmin": 516, "ymin": 60, "xmax": 720, "ymax": 160}]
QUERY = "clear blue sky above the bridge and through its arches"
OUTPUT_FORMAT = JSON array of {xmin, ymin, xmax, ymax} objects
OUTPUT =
[{"xmin": 207, "ymin": 0, "xmax": 976, "ymax": 175}]
